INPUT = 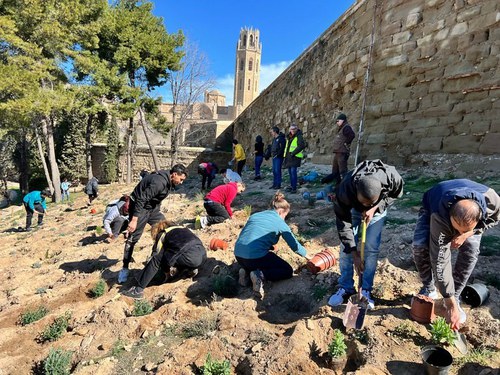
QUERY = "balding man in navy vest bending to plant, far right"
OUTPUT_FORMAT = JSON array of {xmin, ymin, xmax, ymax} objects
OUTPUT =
[{"xmin": 413, "ymin": 179, "xmax": 500, "ymax": 330}]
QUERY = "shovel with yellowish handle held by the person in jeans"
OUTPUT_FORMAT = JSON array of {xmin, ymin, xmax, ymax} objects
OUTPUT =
[{"xmin": 342, "ymin": 220, "xmax": 368, "ymax": 329}]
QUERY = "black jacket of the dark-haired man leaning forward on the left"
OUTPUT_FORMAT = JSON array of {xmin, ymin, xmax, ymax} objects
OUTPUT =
[{"xmin": 130, "ymin": 170, "xmax": 172, "ymax": 217}]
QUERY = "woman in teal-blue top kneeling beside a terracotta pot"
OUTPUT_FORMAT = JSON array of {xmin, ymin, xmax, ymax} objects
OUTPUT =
[{"xmin": 234, "ymin": 192, "xmax": 311, "ymax": 299}]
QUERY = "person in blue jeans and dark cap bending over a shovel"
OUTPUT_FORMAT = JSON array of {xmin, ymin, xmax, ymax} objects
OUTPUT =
[{"xmin": 328, "ymin": 160, "xmax": 404, "ymax": 309}]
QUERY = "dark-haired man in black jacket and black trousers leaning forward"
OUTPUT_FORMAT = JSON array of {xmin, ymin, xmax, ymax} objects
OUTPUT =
[{"xmin": 118, "ymin": 164, "xmax": 188, "ymax": 284}]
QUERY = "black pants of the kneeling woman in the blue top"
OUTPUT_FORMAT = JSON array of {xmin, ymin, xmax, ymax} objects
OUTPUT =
[{"xmin": 236, "ymin": 251, "xmax": 293, "ymax": 281}]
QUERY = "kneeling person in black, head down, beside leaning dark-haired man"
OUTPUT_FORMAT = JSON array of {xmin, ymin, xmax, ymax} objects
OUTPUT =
[{"xmin": 122, "ymin": 220, "xmax": 207, "ymax": 298}]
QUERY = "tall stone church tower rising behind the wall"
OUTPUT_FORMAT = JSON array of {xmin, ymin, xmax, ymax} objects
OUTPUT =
[{"xmin": 233, "ymin": 28, "xmax": 262, "ymax": 115}]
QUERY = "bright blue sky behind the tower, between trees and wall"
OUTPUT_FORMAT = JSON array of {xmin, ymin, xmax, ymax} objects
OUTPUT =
[{"xmin": 152, "ymin": 0, "xmax": 355, "ymax": 105}]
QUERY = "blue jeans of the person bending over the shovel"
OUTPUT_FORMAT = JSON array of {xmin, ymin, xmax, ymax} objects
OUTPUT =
[{"xmin": 339, "ymin": 210, "xmax": 387, "ymax": 293}]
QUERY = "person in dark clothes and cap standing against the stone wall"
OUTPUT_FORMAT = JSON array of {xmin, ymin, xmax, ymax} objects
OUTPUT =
[{"xmin": 322, "ymin": 113, "xmax": 355, "ymax": 186}]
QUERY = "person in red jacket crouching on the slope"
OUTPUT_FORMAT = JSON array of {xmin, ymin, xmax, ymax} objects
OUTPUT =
[{"xmin": 195, "ymin": 182, "xmax": 245, "ymax": 229}]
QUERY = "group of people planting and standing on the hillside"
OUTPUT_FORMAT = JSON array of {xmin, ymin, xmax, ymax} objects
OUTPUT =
[{"xmin": 18, "ymin": 114, "xmax": 500, "ymax": 329}]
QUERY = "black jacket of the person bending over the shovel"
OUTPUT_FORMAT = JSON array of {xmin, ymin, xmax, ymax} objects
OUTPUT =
[{"xmin": 333, "ymin": 159, "xmax": 404, "ymax": 253}]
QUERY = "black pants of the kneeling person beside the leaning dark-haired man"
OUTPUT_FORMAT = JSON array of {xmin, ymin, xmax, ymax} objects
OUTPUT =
[{"xmin": 137, "ymin": 244, "xmax": 207, "ymax": 289}]
